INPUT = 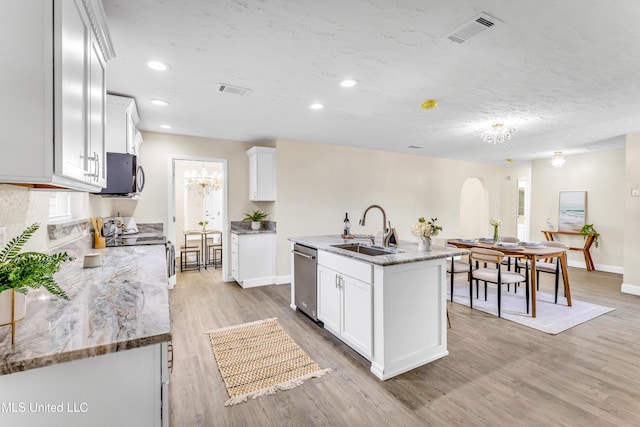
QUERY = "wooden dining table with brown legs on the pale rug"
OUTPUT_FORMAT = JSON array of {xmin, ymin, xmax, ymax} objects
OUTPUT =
[{"xmin": 447, "ymin": 239, "xmax": 571, "ymax": 317}]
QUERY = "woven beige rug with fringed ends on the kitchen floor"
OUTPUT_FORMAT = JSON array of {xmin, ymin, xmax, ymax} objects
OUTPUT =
[{"xmin": 208, "ymin": 319, "xmax": 331, "ymax": 406}]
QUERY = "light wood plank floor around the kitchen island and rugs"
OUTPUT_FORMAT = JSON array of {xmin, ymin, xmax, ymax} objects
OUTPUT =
[{"xmin": 169, "ymin": 268, "xmax": 640, "ymax": 427}]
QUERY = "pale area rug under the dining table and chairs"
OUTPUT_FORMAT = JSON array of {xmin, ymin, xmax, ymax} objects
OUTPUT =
[{"xmin": 447, "ymin": 281, "xmax": 614, "ymax": 335}]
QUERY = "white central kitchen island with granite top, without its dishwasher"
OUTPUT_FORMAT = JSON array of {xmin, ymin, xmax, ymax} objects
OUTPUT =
[{"xmin": 289, "ymin": 236, "xmax": 468, "ymax": 380}]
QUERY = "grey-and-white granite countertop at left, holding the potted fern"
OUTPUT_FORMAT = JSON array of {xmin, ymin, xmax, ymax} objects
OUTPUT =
[{"xmin": 0, "ymin": 245, "xmax": 171, "ymax": 375}]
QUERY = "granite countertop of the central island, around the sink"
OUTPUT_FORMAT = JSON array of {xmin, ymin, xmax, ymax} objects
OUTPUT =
[{"xmin": 289, "ymin": 235, "xmax": 469, "ymax": 266}]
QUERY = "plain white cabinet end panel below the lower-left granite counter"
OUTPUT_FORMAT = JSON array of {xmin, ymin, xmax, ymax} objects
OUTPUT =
[{"xmin": 0, "ymin": 343, "xmax": 169, "ymax": 427}]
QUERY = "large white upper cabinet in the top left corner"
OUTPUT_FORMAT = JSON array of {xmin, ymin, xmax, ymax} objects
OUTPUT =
[{"xmin": 0, "ymin": 0, "xmax": 114, "ymax": 192}]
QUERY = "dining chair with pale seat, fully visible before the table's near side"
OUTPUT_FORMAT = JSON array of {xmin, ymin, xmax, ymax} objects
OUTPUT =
[{"xmin": 468, "ymin": 248, "xmax": 529, "ymax": 317}]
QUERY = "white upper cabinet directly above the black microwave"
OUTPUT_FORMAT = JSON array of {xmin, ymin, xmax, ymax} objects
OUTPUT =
[{"xmin": 106, "ymin": 95, "xmax": 142, "ymax": 155}]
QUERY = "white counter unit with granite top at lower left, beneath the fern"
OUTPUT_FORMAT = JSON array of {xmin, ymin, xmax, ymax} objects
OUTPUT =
[{"xmin": 0, "ymin": 245, "xmax": 171, "ymax": 426}]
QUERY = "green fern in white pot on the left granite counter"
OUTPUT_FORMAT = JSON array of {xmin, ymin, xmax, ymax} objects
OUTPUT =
[{"xmin": 0, "ymin": 223, "xmax": 73, "ymax": 325}]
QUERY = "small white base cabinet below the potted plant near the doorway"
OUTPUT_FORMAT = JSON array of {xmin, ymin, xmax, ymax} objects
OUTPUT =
[{"xmin": 231, "ymin": 233, "xmax": 276, "ymax": 288}]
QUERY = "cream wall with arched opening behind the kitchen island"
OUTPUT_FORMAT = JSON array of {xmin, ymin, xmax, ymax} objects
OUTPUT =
[{"xmin": 276, "ymin": 140, "xmax": 521, "ymax": 276}]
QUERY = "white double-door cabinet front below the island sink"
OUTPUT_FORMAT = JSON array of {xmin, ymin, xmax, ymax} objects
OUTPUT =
[{"xmin": 318, "ymin": 251, "xmax": 373, "ymax": 360}]
